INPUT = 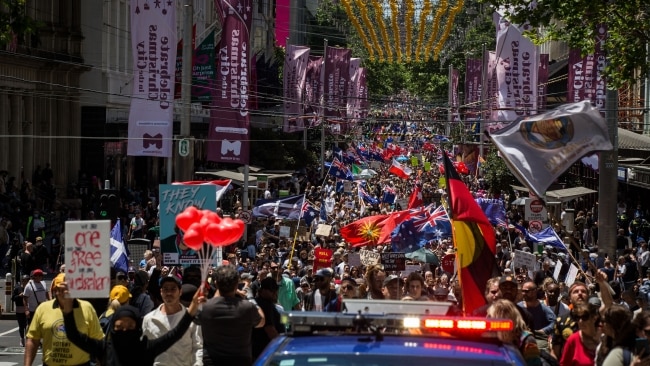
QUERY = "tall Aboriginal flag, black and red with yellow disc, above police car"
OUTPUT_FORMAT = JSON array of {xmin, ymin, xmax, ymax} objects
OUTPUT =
[{"xmin": 443, "ymin": 154, "xmax": 499, "ymax": 314}]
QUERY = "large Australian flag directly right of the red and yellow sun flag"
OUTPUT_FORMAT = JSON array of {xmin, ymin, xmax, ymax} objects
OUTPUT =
[{"xmin": 391, "ymin": 205, "xmax": 451, "ymax": 253}]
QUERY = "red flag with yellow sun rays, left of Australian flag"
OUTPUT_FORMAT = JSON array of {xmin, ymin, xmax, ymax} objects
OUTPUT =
[{"xmin": 340, "ymin": 215, "xmax": 395, "ymax": 247}]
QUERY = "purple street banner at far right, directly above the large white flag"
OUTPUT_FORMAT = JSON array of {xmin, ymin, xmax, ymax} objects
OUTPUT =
[{"xmin": 567, "ymin": 25, "xmax": 607, "ymax": 116}]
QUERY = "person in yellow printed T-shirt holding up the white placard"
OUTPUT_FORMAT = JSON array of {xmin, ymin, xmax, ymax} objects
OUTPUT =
[{"xmin": 24, "ymin": 273, "xmax": 104, "ymax": 366}]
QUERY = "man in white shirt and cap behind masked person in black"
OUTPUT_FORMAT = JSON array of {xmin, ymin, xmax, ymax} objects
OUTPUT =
[{"xmin": 142, "ymin": 276, "xmax": 203, "ymax": 366}]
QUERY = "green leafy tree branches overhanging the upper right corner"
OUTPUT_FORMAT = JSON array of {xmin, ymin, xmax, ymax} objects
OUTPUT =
[{"xmin": 484, "ymin": 0, "xmax": 650, "ymax": 88}]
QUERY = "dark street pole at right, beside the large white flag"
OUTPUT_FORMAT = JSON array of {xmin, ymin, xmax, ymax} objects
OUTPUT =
[{"xmin": 598, "ymin": 90, "xmax": 618, "ymax": 258}]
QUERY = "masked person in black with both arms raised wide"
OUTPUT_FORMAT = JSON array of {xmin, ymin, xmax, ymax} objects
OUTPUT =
[{"xmin": 59, "ymin": 283, "xmax": 205, "ymax": 366}]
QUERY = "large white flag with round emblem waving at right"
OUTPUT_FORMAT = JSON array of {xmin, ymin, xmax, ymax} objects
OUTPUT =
[{"xmin": 490, "ymin": 101, "xmax": 612, "ymax": 197}]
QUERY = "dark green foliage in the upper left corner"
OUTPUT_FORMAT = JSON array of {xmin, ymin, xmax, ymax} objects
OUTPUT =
[{"xmin": 0, "ymin": 0, "xmax": 39, "ymax": 48}]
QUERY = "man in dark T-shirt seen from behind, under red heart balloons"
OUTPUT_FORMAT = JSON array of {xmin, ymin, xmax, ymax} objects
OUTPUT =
[{"xmin": 198, "ymin": 265, "xmax": 265, "ymax": 366}]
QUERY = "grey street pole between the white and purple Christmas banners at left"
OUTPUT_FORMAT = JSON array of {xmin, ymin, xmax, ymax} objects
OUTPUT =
[{"xmin": 174, "ymin": 0, "xmax": 194, "ymax": 181}]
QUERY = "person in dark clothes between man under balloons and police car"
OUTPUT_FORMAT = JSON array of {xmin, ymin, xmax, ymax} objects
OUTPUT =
[{"xmin": 252, "ymin": 277, "xmax": 285, "ymax": 359}]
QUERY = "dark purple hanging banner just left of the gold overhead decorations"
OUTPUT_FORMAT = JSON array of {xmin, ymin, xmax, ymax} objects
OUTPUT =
[{"xmin": 324, "ymin": 47, "xmax": 352, "ymax": 119}]
